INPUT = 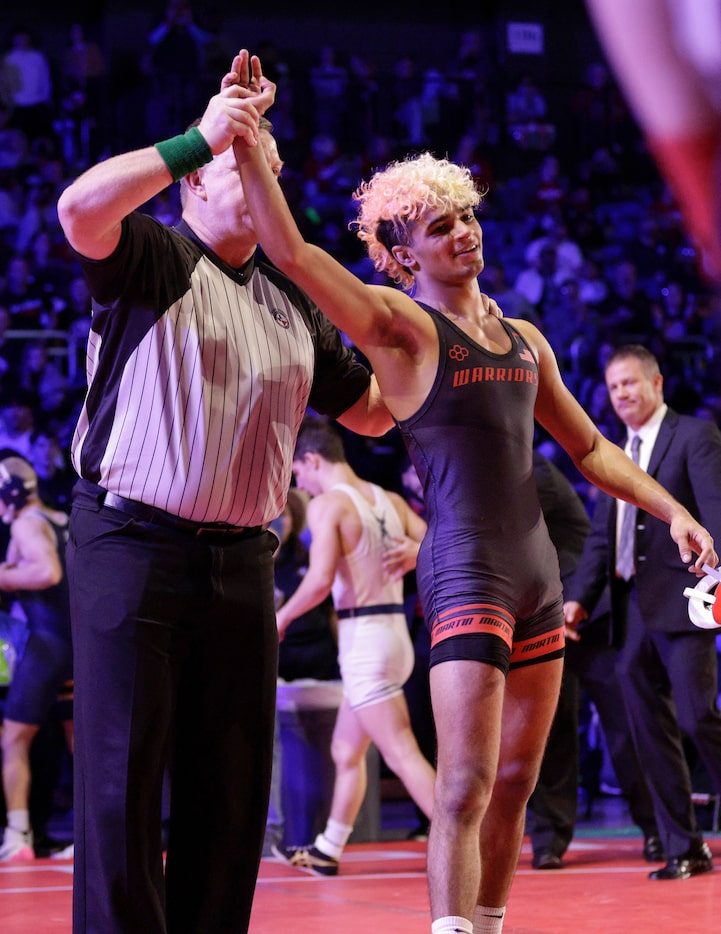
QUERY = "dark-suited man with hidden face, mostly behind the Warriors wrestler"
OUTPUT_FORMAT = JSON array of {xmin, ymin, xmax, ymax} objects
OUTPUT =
[{"xmin": 528, "ymin": 450, "xmax": 664, "ymax": 869}]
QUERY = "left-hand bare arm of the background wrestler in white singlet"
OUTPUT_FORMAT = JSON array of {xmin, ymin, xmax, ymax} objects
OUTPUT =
[{"xmin": 276, "ymin": 494, "xmax": 342, "ymax": 638}]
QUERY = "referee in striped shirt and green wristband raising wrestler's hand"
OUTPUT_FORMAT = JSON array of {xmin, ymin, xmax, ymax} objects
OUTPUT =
[{"xmin": 58, "ymin": 53, "xmax": 392, "ymax": 934}]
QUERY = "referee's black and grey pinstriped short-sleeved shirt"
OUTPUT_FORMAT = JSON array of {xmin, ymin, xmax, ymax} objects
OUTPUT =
[{"xmin": 72, "ymin": 213, "xmax": 368, "ymax": 526}]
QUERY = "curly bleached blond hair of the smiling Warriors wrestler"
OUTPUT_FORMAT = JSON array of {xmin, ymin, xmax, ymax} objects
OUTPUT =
[{"xmin": 350, "ymin": 152, "xmax": 485, "ymax": 290}]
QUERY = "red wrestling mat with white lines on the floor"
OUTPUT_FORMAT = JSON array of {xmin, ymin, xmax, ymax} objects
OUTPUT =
[{"xmin": 0, "ymin": 836, "xmax": 721, "ymax": 934}]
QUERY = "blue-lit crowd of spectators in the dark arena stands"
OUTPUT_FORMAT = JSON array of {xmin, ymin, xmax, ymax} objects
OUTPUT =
[{"xmin": 0, "ymin": 7, "xmax": 721, "ymax": 504}]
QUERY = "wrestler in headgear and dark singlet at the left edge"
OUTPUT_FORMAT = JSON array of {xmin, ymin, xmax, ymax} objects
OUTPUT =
[{"xmin": 0, "ymin": 454, "xmax": 73, "ymax": 860}]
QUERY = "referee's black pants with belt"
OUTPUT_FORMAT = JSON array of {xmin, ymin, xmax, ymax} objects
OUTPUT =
[{"xmin": 67, "ymin": 481, "xmax": 278, "ymax": 934}]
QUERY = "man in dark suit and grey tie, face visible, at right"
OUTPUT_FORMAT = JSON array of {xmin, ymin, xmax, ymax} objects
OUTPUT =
[{"xmin": 564, "ymin": 344, "xmax": 721, "ymax": 879}]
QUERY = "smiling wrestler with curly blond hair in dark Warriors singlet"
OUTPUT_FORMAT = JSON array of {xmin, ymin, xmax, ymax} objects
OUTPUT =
[{"xmin": 234, "ymin": 57, "xmax": 716, "ymax": 934}]
